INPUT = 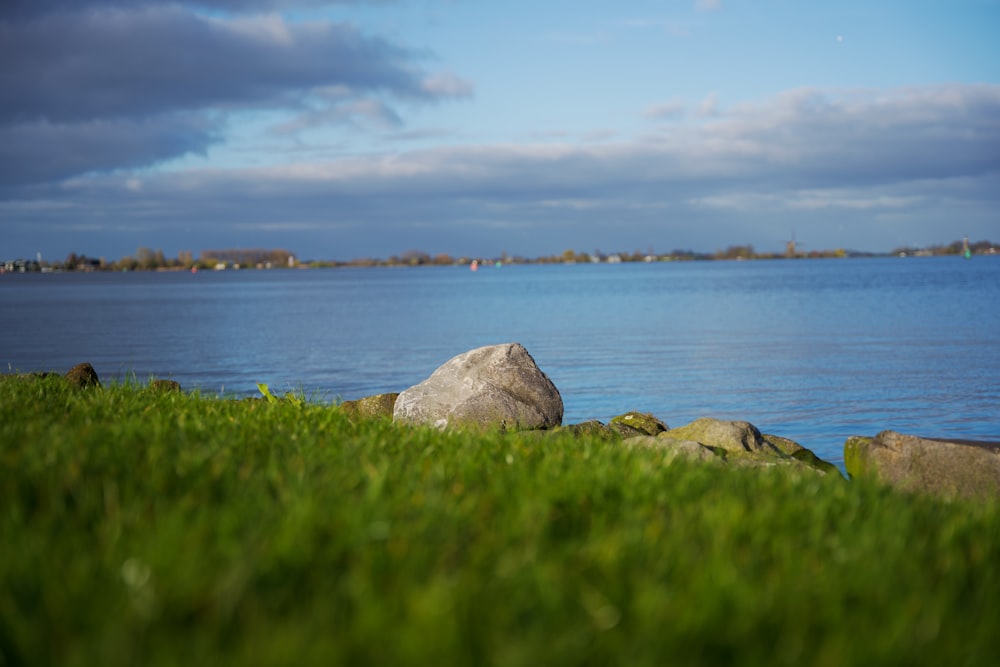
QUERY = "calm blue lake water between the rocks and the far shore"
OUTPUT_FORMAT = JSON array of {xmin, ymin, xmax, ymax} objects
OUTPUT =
[{"xmin": 0, "ymin": 257, "xmax": 1000, "ymax": 462}]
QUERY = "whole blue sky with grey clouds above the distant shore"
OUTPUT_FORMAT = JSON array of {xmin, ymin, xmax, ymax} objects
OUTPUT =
[{"xmin": 0, "ymin": 0, "xmax": 1000, "ymax": 261}]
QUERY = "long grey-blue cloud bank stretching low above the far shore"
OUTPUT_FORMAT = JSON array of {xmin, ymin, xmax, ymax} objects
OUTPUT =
[{"xmin": 0, "ymin": 84, "xmax": 1000, "ymax": 258}]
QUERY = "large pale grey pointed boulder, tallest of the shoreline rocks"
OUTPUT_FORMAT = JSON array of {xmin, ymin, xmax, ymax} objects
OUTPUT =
[{"xmin": 393, "ymin": 343, "xmax": 563, "ymax": 430}]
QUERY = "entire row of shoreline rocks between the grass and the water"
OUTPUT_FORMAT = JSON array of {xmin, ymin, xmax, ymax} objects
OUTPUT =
[{"xmin": 17, "ymin": 350, "xmax": 1000, "ymax": 499}]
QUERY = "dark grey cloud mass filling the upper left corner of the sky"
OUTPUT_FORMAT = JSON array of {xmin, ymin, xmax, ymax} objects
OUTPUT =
[{"xmin": 0, "ymin": 0, "xmax": 473, "ymax": 187}]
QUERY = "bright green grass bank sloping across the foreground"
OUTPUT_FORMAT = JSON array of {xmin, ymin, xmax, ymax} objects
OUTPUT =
[{"xmin": 0, "ymin": 378, "xmax": 1000, "ymax": 667}]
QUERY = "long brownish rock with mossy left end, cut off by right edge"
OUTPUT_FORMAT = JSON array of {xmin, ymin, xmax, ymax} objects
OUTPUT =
[{"xmin": 844, "ymin": 431, "xmax": 1000, "ymax": 498}]
